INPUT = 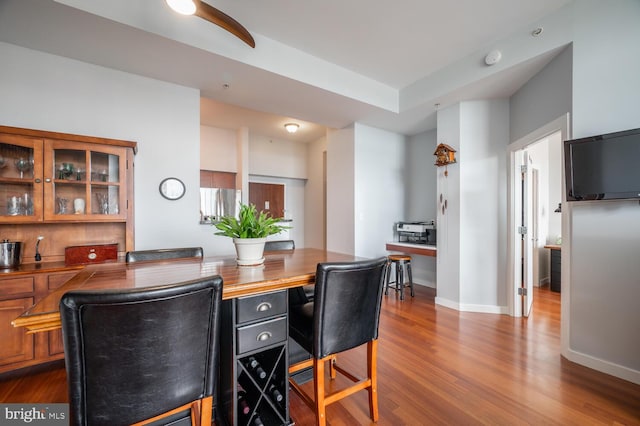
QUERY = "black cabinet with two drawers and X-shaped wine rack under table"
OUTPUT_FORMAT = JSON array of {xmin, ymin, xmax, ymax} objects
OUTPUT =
[{"xmin": 217, "ymin": 291, "xmax": 291, "ymax": 426}]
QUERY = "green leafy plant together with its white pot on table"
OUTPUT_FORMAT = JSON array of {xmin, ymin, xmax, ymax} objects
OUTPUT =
[{"xmin": 213, "ymin": 203, "xmax": 290, "ymax": 266}]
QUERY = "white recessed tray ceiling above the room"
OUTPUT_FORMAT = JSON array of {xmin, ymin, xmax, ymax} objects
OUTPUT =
[{"xmin": 0, "ymin": 0, "xmax": 571, "ymax": 142}]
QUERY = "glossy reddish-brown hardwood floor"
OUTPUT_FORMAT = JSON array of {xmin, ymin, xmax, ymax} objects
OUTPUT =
[{"xmin": 0, "ymin": 286, "xmax": 640, "ymax": 426}]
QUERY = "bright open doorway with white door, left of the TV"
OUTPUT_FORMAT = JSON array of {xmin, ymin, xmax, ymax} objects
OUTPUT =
[{"xmin": 508, "ymin": 114, "xmax": 569, "ymax": 317}]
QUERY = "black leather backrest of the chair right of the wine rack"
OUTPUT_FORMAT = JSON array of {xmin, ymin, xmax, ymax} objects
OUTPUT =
[{"xmin": 312, "ymin": 257, "xmax": 387, "ymax": 358}]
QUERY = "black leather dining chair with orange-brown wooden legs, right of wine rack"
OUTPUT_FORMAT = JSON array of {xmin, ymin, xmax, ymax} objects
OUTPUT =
[{"xmin": 289, "ymin": 257, "xmax": 387, "ymax": 425}]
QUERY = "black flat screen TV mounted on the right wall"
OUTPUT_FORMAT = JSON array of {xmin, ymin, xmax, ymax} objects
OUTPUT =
[{"xmin": 564, "ymin": 129, "xmax": 640, "ymax": 201}]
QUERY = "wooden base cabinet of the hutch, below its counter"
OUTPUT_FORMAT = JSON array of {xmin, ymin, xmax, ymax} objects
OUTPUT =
[{"xmin": 0, "ymin": 266, "xmax": 79, "ymax": 373}]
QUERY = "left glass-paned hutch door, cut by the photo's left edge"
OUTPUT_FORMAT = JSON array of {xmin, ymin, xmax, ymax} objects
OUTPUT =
[{"xmin": 0, "ymin": 135, "xmax": 42, "ymax": 222}]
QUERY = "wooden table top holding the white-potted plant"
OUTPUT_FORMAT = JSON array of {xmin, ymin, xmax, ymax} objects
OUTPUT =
[{"xmin": 11, "ymin": 249, "xmax": 358, "ymax": 333}]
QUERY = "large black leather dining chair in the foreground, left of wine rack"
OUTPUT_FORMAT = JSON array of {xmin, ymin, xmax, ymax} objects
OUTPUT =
[{"xmin": 60, "ymin": 276, "xmax": 222, "ymax": 426}]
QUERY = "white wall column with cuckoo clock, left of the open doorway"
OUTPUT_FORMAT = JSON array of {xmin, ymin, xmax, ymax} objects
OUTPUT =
[{"xmin": 436, "ymin": 99, "xmax": 509, "ymax": 313}]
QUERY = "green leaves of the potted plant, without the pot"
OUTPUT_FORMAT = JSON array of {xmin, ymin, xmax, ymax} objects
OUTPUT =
[{"xmin": 213, "ymin": 204, "xmax": 291, "ymax": 238}]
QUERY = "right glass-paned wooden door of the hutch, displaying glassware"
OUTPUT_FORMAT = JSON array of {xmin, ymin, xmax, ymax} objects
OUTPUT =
[{"xmin": 45, "ymin": 141, "xmax": 125, "ymax": 221}]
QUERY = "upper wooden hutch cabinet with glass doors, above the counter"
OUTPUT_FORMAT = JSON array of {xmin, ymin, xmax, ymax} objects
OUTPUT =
[{"xmin": 0, "ymin": 126, "xmax": 137, "ymax": 261}]
